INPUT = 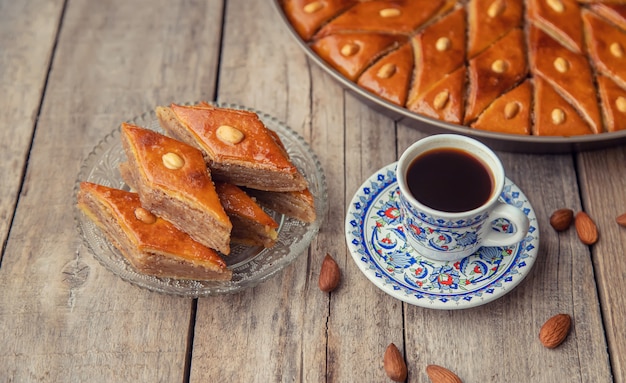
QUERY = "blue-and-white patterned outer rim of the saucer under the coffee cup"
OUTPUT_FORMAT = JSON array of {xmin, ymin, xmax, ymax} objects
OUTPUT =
[{"xmin": 345, "ymin": 162, "xmax": 539, "ymax": 310}]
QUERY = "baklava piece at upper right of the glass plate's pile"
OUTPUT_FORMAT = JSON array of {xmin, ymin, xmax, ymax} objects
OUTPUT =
[{"xmin": 156, "ymin": 103, "xmax": 308, "ymax": 191}]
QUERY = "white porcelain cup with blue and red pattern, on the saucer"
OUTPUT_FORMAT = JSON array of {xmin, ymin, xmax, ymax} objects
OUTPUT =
[{"xmin": 396, "ymin": 134, "xmax": 529, "ymax": 261}]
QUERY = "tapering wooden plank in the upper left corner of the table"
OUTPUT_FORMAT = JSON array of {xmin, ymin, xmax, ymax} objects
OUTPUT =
[{"xmin": 0, "ymin": 0, "xmax": 63, "ymax": 262}]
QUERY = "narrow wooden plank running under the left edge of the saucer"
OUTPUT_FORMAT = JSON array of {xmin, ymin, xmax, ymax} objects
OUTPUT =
[{"xmin": 320, "ymin": 92, "xmax": 405, "ymax": 382}]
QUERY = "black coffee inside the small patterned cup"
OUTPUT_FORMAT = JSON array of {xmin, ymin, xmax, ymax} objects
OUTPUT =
[{"xmin": 406, "ymin": 148, "xmax": 493, "ymax": 213}]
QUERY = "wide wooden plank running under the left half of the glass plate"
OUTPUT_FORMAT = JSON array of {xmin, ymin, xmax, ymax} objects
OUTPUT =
[{"xmin": 0, "ymin": 0, "xmax": 222, "ymax": 382}]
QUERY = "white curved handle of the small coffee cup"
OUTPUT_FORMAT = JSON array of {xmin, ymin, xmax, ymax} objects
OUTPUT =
[{"xmin": 481, "ymin": 203, "xmax": 530, "ymax": 246}]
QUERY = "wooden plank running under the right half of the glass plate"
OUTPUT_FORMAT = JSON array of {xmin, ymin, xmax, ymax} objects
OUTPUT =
[{"xmin": 190, "ymin": 0, "xmax": 330, "ymax": 382}]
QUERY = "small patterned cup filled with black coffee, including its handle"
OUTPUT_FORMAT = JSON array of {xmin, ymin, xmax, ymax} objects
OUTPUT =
[{"xmin": 396, "ymin": 134, "xmax": 529, "ymax": 261}]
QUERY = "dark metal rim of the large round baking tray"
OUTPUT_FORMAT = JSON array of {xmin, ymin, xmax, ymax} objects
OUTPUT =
[{"xmin": 272, "ymin": 0, "xmax": 626, "ymax": 153}]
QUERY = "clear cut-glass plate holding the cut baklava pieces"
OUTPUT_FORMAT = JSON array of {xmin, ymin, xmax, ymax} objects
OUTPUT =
[{"xmin": 74, "ymin": 102, "xmax": 328, "ymax": 298}]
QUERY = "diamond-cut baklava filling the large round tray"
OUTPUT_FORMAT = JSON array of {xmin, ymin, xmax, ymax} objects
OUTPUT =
[{"xmin": 281, "ymin": 0, "xmax": 626, "ymax": 137}]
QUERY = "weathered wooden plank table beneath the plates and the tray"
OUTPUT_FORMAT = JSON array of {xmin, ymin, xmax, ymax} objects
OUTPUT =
[{"xmin": 0, "ymin": 0, "xmax": 626, "ymax": 383}]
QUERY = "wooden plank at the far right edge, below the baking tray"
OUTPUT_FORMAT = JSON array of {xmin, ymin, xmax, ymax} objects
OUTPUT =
[{"xmin": 577, "ymin": 147, "xmax": 626, "ymax": 383}]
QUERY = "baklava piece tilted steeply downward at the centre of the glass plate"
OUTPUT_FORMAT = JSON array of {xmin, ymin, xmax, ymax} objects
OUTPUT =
[{"xmin": 120, "ymin": 123, "xmax": 232, "ymax": 254}]
